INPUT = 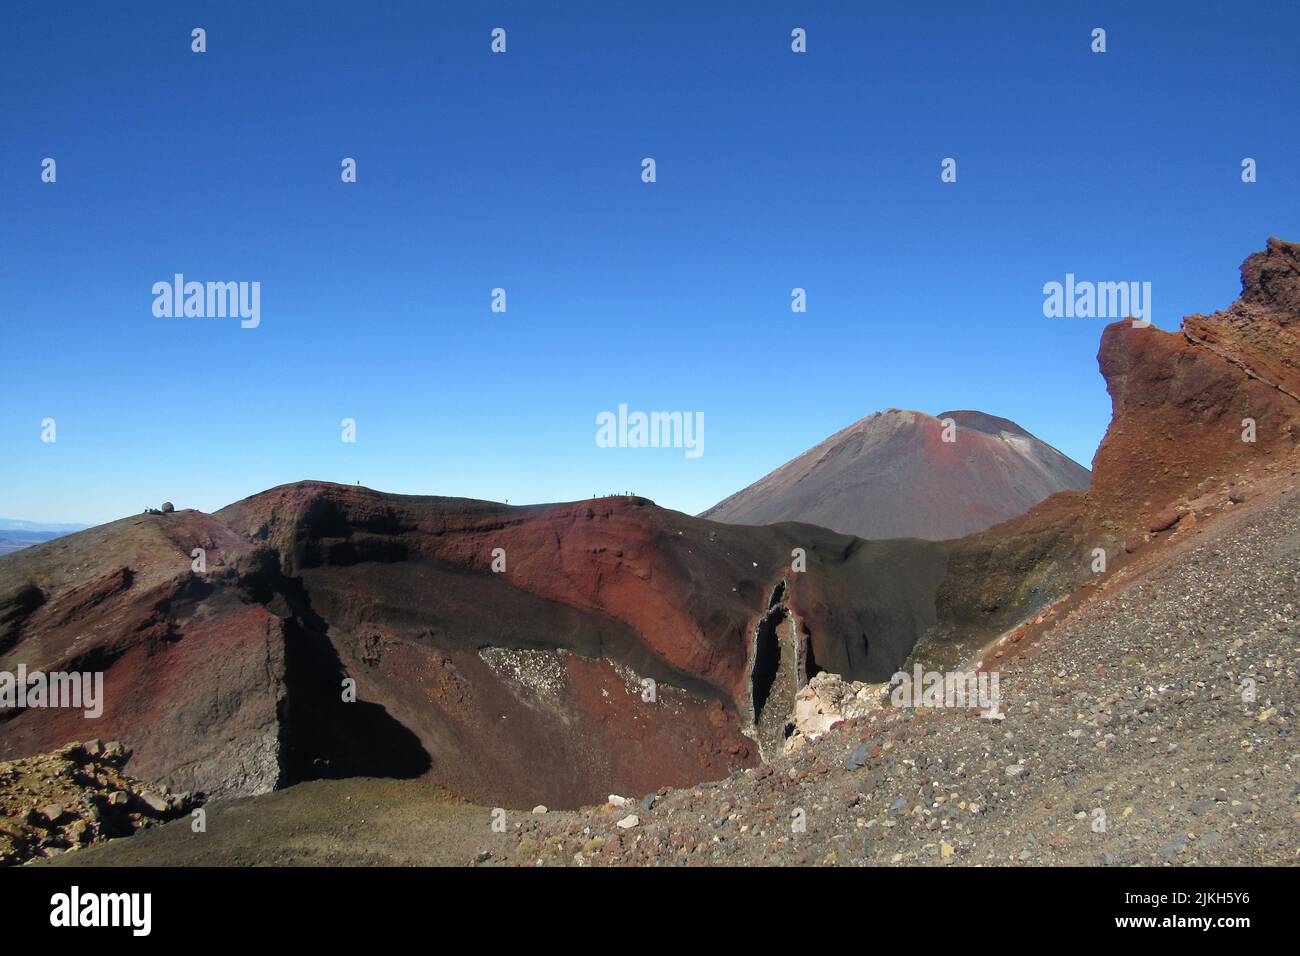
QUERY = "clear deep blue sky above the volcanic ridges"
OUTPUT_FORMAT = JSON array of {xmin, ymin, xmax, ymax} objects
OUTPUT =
[{"xmin": 0, "ymin": 0, "xmax": 1300, "ymax": 522}]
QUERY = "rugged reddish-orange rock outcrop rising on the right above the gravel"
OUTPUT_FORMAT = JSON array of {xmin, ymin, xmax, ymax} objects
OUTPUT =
[{"xmin": 917, "ymin": 239, "xmax": 1300, "ymax": 665}]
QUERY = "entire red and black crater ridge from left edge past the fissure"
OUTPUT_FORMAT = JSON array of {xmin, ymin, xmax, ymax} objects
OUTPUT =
[{"xmin": 0, "ymin": 483, "xmax": 946, "ymax": 806}]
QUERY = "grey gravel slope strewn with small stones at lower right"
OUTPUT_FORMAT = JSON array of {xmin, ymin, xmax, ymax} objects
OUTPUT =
[{"xmin": 509, "ymin": 490, "xmax": 1300, "ymax": 865}]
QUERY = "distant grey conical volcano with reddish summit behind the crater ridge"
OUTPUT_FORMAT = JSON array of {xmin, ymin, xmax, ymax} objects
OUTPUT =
[{"xmin": 702, "ymin": 408, "xmax": 1088, "ymax": 540}]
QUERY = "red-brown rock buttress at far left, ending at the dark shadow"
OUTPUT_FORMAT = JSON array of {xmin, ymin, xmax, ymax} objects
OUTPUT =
[{"xmin": 0, "ymin": 511, "xmax": 285, "ymax": 793}]
